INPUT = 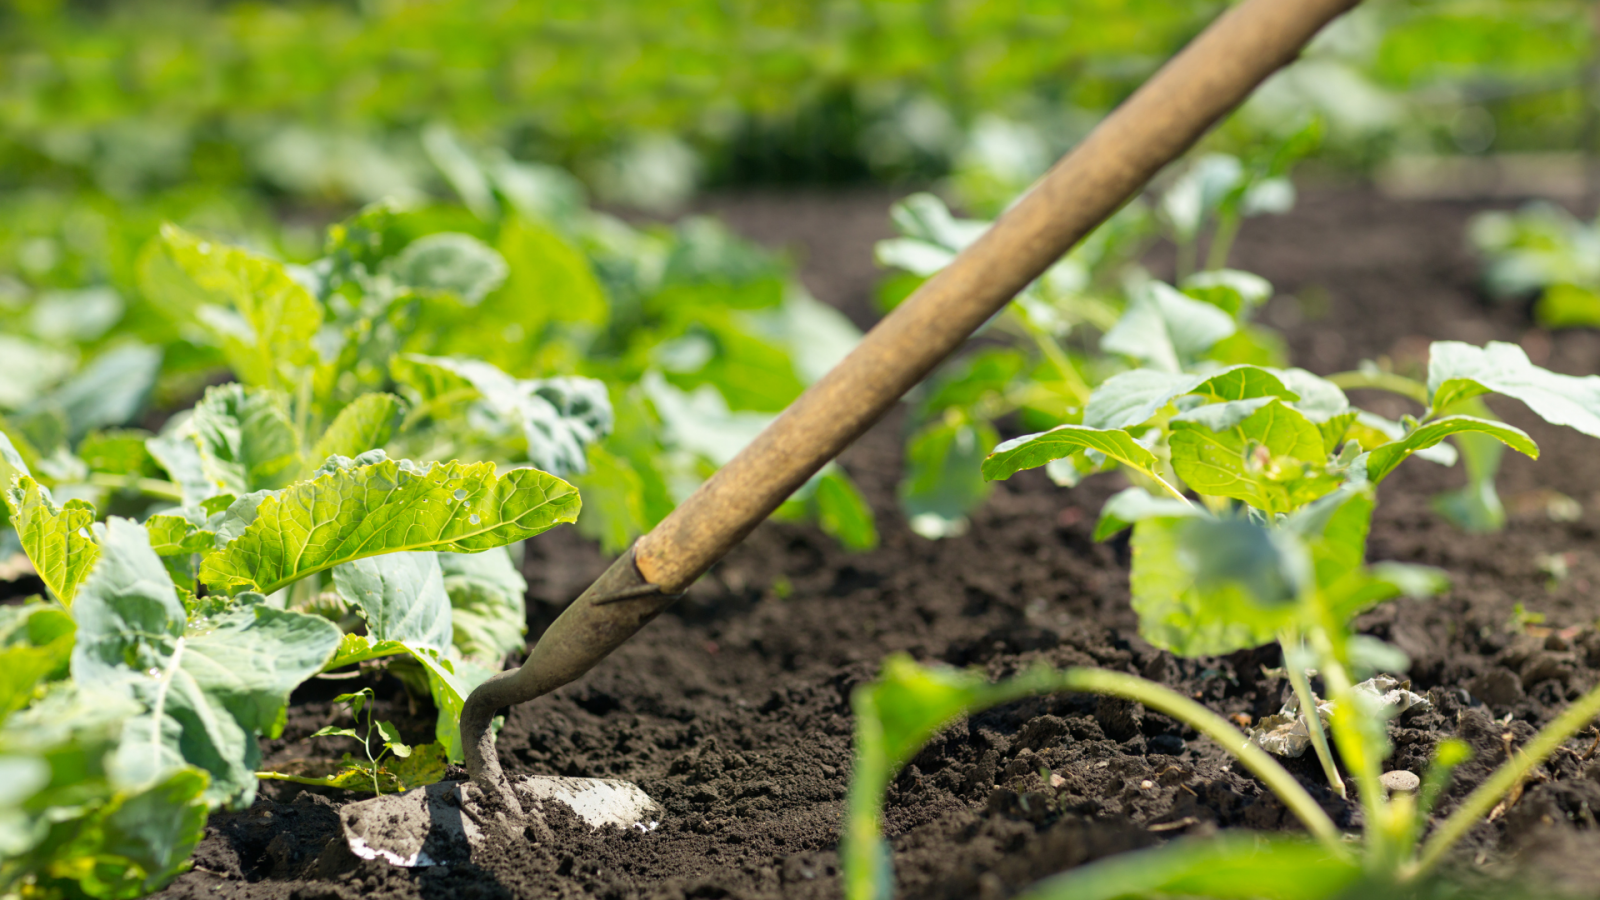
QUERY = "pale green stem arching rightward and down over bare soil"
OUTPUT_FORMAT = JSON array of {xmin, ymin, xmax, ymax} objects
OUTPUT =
[{"xmin": 1059, "ymin": 669, "xmax": 1349, "ymax": 858}]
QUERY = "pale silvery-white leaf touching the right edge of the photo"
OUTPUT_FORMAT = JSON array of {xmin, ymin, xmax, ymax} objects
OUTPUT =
[{"xmin": 1427, "ymin": 341, "xmax": 1600, "ymax": 437}]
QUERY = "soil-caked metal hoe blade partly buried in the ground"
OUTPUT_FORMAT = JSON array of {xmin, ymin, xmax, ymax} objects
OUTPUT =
[{"xmin": 339, "ymin": 775, "xmax": 659, "ymax": 866}]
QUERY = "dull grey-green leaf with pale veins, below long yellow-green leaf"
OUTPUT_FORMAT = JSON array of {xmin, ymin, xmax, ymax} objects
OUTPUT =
[{"xmin": 72, "ymin": 517, "xmax": 339, "ymax": 804}]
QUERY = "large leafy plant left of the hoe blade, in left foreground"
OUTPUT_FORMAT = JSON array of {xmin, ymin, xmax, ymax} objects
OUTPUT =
[{"xmin": 0, "ymin": 416, "xmax": 579, "ymax": 897}]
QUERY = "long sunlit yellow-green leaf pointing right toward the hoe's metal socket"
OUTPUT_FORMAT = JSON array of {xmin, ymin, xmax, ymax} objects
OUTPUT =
[{"xmin": 200, "ymin": 452, "xmax": 579, "ymax": 594}]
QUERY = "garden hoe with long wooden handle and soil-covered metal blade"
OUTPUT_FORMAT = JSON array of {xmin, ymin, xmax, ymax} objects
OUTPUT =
[{"xmin": 341, "ymin": 0, "xmax": 1358, "ymax": 866}]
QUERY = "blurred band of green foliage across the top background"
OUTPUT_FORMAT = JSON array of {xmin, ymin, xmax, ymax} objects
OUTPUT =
[{"xmin": 0, "ymin": 0, "xmax": 1600, "ymax": 374}]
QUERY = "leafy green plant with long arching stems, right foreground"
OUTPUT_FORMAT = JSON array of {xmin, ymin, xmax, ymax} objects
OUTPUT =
[{"xmin": 846, "ymin": 331, "xmax": 1600, "ymax": 897}]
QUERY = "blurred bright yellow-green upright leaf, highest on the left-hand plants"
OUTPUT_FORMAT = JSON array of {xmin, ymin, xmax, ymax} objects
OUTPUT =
[{"xmin": 150, "ymin": 224, "xmax": 322, "ymax": 389}]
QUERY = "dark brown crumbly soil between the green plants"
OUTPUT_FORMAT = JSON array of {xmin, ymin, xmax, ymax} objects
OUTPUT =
[{"xmin": 156, "ymin": 192, "xmax": 1600, "ymax": 900}]
